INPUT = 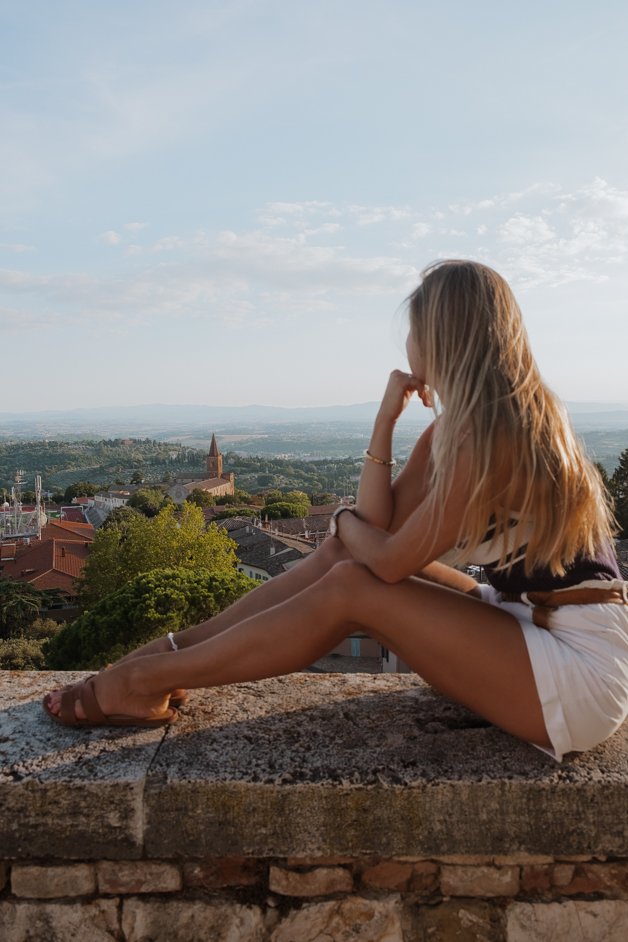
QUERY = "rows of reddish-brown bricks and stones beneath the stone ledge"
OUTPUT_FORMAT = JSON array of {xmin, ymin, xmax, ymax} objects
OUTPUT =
[{"xmin": 0, "ymin": 854, "xmax": 628, "ymax": 942}]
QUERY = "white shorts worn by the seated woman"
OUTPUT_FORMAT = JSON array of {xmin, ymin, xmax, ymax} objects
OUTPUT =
[{"xmin": 480, "ymin": 585, "xmax": 628, "ymax": 762}]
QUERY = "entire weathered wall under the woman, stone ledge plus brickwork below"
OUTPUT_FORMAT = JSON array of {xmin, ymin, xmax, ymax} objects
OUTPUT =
[{"xmin": 0, "ymin": 672, "xmax": 628, "ymax": 942}]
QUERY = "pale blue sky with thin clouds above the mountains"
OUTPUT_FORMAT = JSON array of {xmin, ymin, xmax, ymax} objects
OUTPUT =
[{"xmin": 0, "ymin": 0, "xmax": 628, "ymax": 412}]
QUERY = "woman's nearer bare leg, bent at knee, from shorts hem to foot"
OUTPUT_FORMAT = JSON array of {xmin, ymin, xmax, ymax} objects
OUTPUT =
[{"xmin": 55, "ymin": 560, "xmax": 550, "ymax": 746}]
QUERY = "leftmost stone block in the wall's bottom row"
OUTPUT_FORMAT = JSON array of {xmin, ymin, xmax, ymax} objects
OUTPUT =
[{"xmin": 0, "ymin": 900, "xmax": 120, "ymax": 942}]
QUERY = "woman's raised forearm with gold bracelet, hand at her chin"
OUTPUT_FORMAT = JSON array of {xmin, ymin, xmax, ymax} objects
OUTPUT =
[{"xmin": 356, "ymin": 370, "xmax": 425, "ymax": 530}]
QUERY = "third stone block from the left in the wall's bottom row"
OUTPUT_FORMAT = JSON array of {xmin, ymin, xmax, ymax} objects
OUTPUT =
[{"xmin": 270, "ymin": 897, "xmax": 403, "ymax": 942}]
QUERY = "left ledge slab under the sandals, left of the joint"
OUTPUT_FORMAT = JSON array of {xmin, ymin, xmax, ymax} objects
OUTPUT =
[{"xmin": 0, "ymin": 671, "xmax": 164, "ymax": 858}]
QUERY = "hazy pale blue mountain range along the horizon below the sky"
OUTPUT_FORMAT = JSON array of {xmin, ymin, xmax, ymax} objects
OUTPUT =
[{"xmin": 0, "ymin": 401, "xmax": 628, "ymax": 438}]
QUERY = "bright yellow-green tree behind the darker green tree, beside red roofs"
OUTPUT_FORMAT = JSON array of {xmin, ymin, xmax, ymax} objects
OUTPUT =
[{"xmin": 79, "ymin": 503, "xmax": 236, "ymax": 608}]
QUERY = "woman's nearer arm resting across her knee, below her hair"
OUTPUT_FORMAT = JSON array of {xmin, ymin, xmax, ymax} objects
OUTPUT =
[{"xmin": 338, "ymin": 442, "xmax": 470, "ymax": 582}]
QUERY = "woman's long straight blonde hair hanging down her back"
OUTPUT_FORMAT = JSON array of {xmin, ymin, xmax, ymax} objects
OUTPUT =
[{"xmin": 408, "ymin": 260, "xmax": 613, "ymax": 575}]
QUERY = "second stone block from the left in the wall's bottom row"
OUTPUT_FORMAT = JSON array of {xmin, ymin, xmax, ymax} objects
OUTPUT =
[{"xmin": 122, "ymin": 898, "xmax": 264, "ymax": 942}]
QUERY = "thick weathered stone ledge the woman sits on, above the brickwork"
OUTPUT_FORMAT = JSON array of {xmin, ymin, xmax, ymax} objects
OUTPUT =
[{"xmin": 0, "ymin": 671, "xmax": 628, "ymax": 860}]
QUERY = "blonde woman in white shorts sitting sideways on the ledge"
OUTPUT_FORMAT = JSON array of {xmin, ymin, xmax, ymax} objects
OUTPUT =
[{"xmin": 44, "ymin": 261, "xmax": 628, "ymax": 761}]
